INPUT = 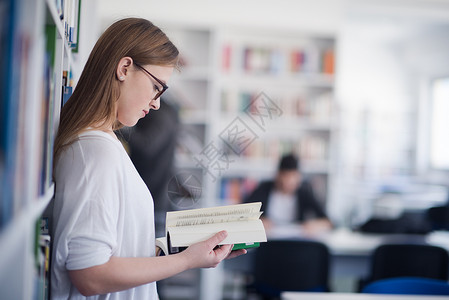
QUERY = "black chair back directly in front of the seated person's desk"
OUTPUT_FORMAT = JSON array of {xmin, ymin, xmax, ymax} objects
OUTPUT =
[{"xmin": 253, "ymin": 240, "xmax": 329, "ymax": 296}]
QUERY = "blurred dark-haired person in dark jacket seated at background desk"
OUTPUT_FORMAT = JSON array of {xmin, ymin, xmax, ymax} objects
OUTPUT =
[{"xmin": 245, "ymin": 154, "xmax": 332, "ymax": 235}]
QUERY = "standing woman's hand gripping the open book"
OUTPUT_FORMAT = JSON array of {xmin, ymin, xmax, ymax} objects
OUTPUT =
[{"xmin": 180, "ymin": 231, "xmax": 246, "ymax": 268}]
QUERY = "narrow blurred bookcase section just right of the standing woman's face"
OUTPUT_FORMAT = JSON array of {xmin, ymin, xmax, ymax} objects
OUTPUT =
[{"xmin": 156, "ymin": 23, "xmax": 215, "ymax": 299}]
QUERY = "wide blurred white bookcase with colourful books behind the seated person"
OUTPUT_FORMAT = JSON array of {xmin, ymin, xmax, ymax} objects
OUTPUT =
[{"xmin": 212, "ymin": 29, "xmax": 337, "ymax": 209}]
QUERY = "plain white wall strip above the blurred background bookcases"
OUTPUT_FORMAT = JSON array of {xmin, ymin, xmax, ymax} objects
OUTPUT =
[{"xmin": 95, "ymin": 0, "xmax": 347, "ymax": 33}]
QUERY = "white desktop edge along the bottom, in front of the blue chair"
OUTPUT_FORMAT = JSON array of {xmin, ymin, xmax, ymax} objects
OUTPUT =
[{"xmin": 281, "ymin": 292, "xmax": 449, "ymax": 300}]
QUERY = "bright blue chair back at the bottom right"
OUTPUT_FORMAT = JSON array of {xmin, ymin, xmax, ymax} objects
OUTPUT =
[{"xmin": 362, "ymin": 277, "xmax": 449, "ymax": 295}]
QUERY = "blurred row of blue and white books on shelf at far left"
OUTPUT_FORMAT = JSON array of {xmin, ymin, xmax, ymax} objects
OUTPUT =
[{"xmin": 0, "ymin": 1, "xmax": 72, "ymax": 228}]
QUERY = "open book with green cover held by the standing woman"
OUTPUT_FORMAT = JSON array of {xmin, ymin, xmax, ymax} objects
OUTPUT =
[{"xmin": 156, "ymin": 202, "xmax": 267, "ymax": 255}]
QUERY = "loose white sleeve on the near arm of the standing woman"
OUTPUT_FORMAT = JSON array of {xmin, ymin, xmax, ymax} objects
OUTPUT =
[{"xmin": 57, "ymin": 137, "xmax": 122, "ymax": 270}]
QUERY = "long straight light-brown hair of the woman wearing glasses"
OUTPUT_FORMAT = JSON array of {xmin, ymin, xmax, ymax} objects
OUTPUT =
[{"xmin": 54, "ymin": 18, "xmax": 179, "ymax": 159}]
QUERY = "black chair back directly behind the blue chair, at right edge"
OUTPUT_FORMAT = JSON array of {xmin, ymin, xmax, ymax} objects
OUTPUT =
[{"xmin": 370, "ymin": 244, "xmax": 449, "ymax": 281}]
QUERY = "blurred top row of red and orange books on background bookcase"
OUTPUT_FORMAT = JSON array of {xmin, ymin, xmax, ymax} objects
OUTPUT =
[{"xmin": 222, "ymin": 45, "xmax": 335, "ymax": 75}]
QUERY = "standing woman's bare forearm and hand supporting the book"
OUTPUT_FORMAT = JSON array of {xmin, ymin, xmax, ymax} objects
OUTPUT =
[{"xmin": 69, "ymin": 231, "xmax": 234, "ymax": 296}]
